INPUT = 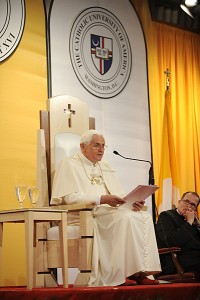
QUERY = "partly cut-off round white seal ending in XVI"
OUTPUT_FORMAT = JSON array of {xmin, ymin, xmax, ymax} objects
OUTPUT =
[{"xmin": 0, "ymin": 0, "xmax": 25, "ymax": 62}]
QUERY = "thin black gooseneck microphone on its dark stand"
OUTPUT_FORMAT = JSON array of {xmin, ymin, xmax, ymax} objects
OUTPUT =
[{"xmin": 113, "ymin": 150, "xmax": 156, "ymax": 225}]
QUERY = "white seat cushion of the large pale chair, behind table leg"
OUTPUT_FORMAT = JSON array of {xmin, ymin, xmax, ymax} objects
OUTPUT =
[{"xmin": 47, "ymin": 225, "xmax": 79, "ymax": 241}]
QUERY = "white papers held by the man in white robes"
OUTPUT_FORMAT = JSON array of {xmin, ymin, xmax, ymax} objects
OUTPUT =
[{"xmin": 120, "ymin": 185, "xmax": 159, "ymax": 210}]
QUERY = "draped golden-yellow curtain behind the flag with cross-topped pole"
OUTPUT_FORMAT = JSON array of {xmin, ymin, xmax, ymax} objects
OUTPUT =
[{"xmin": 132, "ymin": 0, "xmax": 200, "ymax": 211}]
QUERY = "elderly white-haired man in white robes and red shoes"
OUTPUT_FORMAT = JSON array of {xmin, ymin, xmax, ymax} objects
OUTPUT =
[{"xmin": 51, "ymin": 130, "xmax": 161, "ymax": 286}]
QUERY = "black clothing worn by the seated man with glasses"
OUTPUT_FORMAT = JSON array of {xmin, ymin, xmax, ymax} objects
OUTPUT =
[{"xmin": 156, "ymin": 209, "xmax": 200, "ymax": 274}]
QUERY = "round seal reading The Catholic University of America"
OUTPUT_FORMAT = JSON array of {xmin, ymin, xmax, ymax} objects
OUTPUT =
[{"xmin": 69, "ymin": 7, "xmax": 131, "ymax": 98}]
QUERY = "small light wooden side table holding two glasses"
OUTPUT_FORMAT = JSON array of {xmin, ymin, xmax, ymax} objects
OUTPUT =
[{"xmin": 0, "ymin": 207, "xmax": 68, "ymax": 289}]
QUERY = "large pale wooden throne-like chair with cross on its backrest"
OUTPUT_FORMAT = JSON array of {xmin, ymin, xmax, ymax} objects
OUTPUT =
[{"xmin": 36, "ymin": 95, "xmax": 95, "ymax": 286}]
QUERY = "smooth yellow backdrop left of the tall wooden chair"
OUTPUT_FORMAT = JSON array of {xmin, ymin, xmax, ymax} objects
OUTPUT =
[{"xmin": 0, "ymin": 0, "xmax": 47, "ymax": 286}]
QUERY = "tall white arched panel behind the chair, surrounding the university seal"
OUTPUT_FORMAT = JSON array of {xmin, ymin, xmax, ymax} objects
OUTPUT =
[{"xmin": 44, "ymin": 0, "xmax": 151, "ymax": 213}]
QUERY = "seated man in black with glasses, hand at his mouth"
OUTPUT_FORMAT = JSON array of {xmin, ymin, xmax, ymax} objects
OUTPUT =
[{"xmin": 156, "ymin": 192, "xmax": 200, "ymax": 275}]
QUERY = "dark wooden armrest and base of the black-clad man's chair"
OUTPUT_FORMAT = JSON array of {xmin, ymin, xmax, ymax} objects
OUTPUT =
[{"xmin": 157, "ymin": 247, "xmax": 200, "ymax": 283}]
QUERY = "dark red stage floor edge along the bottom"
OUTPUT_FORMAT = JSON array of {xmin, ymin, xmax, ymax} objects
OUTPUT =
[{"xmin": 0, "ymin": 283, "xmax": 200, "ymax": 300}]
